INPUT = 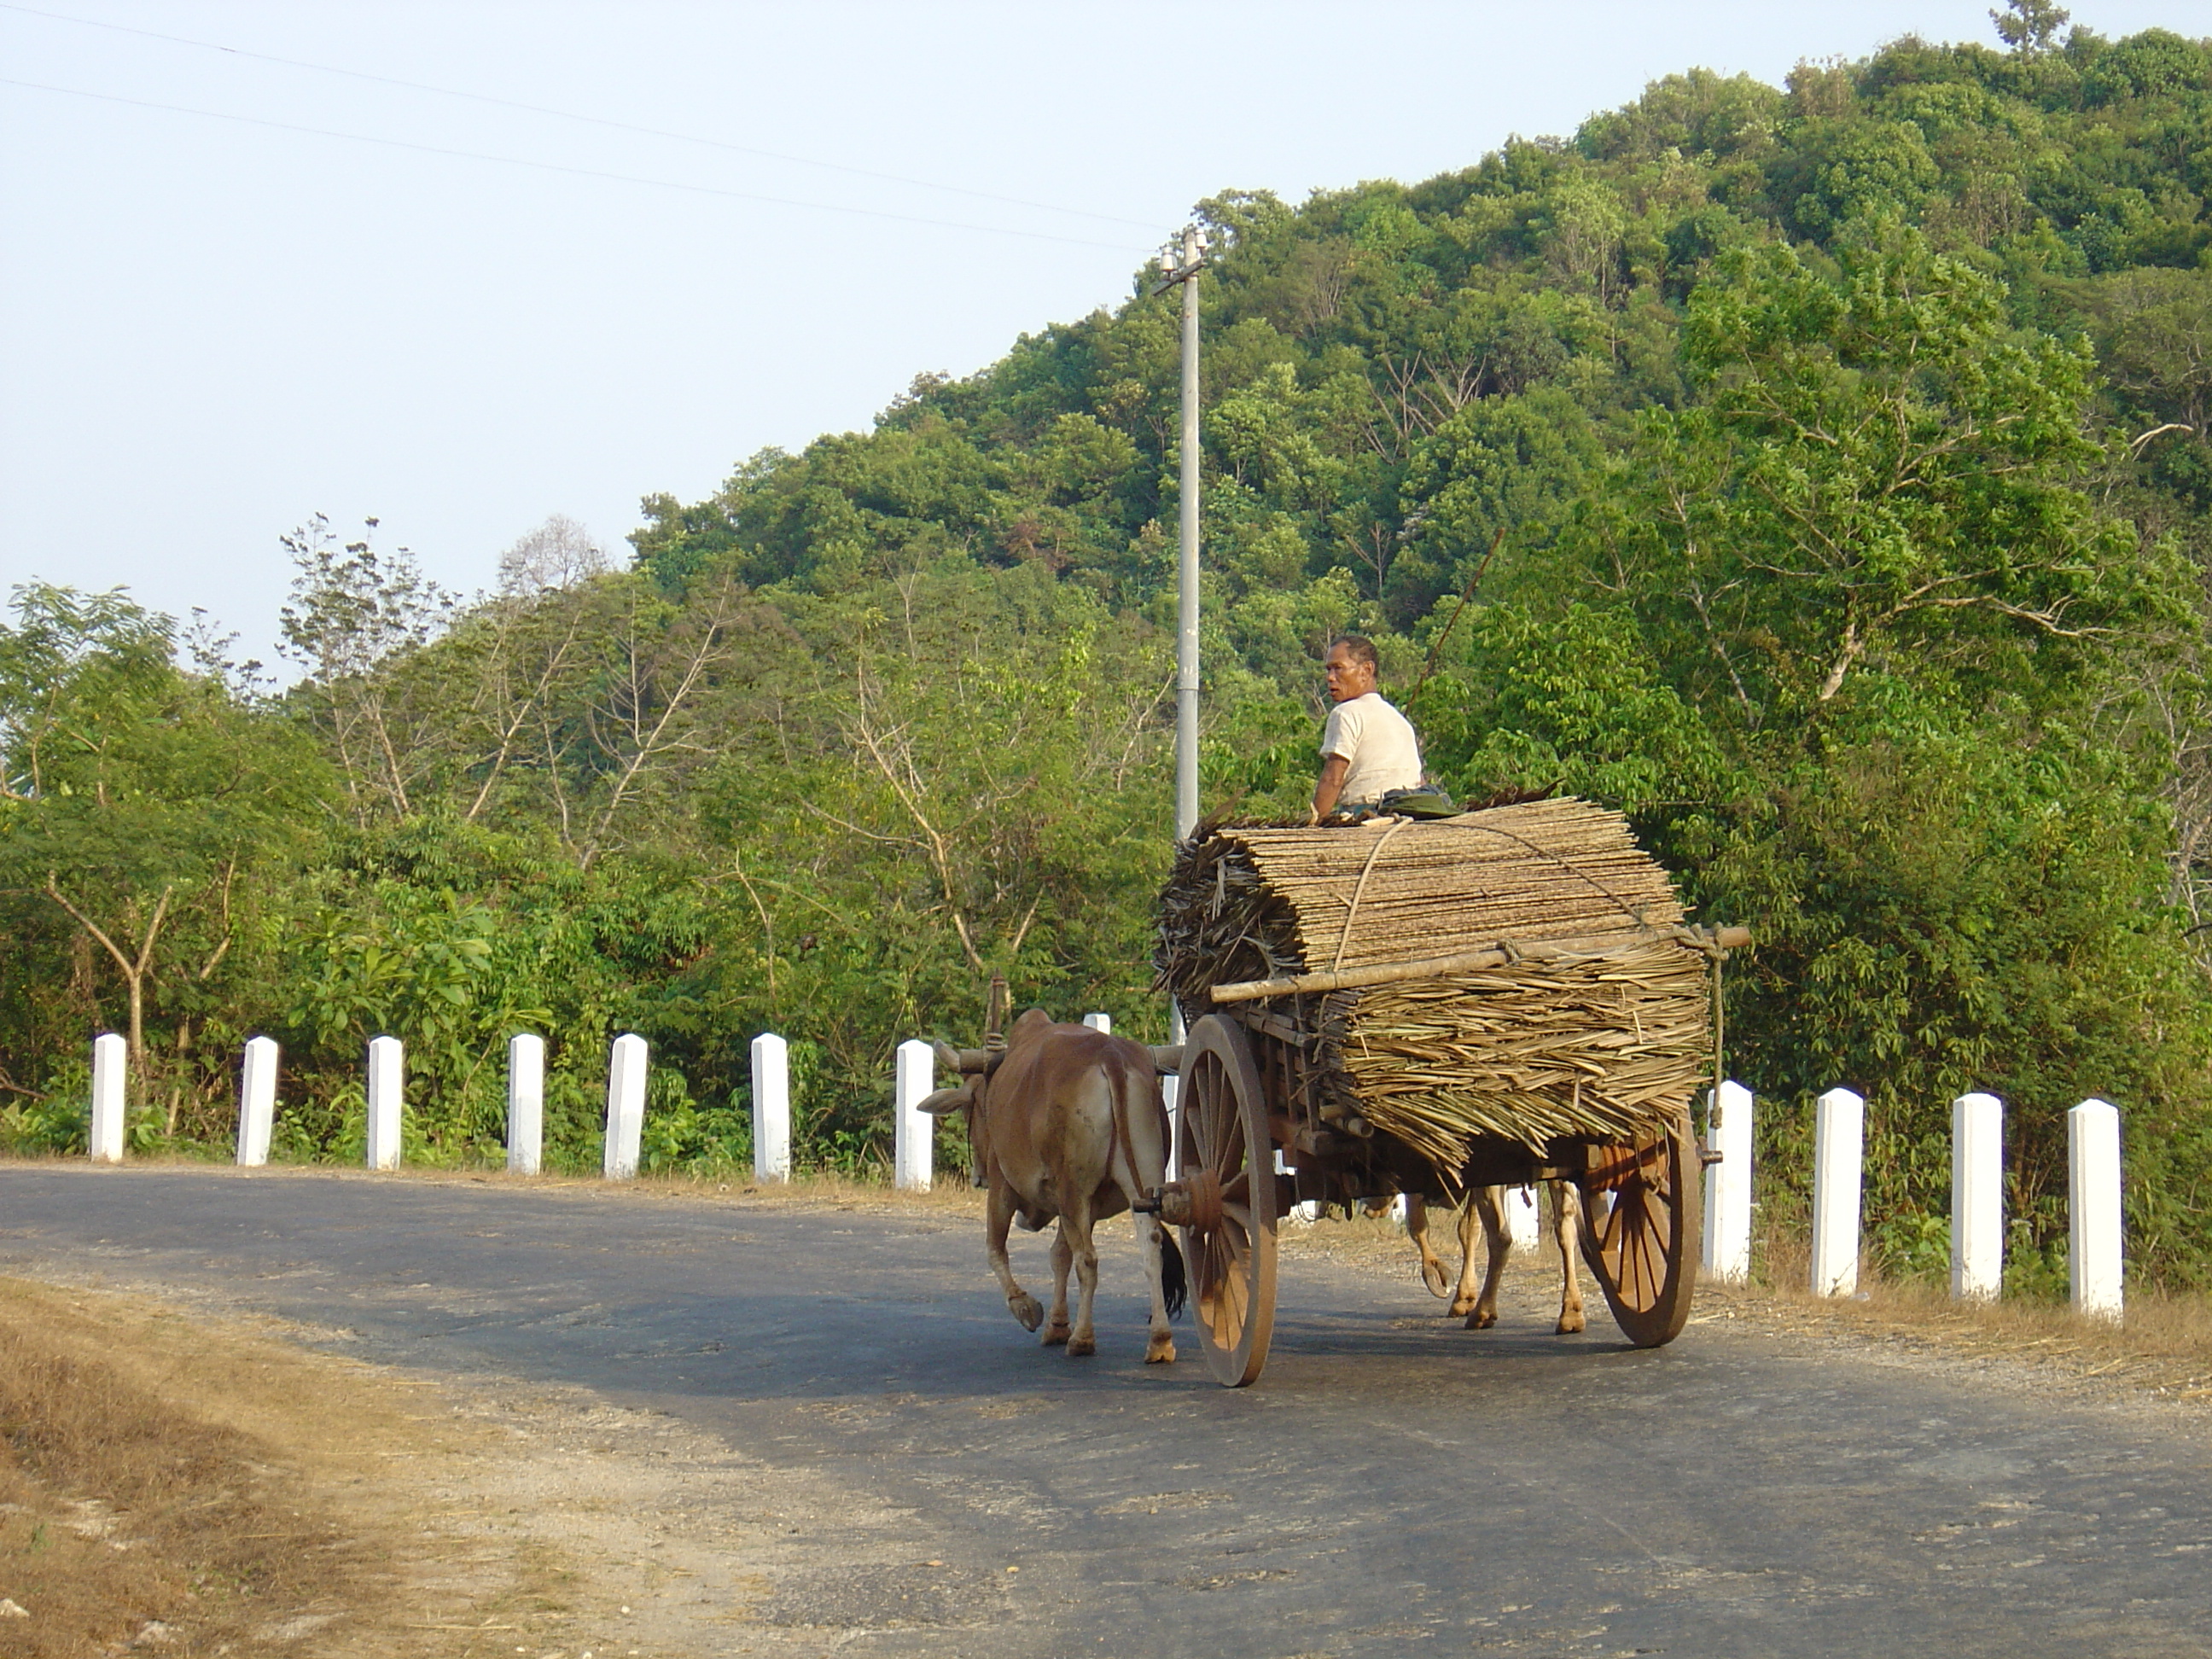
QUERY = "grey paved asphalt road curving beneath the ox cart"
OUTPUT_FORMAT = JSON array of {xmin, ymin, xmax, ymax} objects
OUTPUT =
[{"xmin": 0, "ymin": 1166, "xmax": 2212, "ymax": 1659}]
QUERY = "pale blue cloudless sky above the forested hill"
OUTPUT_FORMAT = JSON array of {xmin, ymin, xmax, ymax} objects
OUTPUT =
[{"xmin": 0, "ymin": 0, "xmax": 2212, "ymax": 655}]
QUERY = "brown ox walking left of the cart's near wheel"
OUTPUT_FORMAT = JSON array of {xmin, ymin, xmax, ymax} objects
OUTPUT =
[{"xmin": 923, "ymin": 1009, "xmax": 1184, "ymax": 1365}]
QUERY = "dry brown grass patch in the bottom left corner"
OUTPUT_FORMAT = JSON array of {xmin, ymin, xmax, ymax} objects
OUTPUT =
[{"xmin": 0, "ymin": 1285, "xmax": 365, "ymax": 1659}]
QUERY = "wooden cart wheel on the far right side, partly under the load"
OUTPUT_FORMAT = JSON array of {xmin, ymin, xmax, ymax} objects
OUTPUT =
[{"xmin": 1580, "ymin": 1124, "xmax": 1703, "ymax": 1348}]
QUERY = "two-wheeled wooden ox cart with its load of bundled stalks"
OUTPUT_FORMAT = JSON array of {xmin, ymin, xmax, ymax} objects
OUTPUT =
[{"xmin": 1148, "ymin": 799, "xmax": 1749, "ymax": 1387}]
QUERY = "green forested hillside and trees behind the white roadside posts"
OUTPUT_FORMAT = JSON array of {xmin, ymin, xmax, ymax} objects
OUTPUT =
[{"xmin": 13, "ymin": 4, "xmax": 2212, "ymax": 1288}]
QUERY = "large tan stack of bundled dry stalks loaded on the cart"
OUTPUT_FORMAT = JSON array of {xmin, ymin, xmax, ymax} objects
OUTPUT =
[{"xmin": 1155, "ymin": 799, "xmax": 1712, "ymax": 1181}]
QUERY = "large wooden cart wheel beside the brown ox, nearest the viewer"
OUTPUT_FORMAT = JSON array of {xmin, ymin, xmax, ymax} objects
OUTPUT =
[{"xmin": 1174, "ymin": 1013, "xmax": 1277, "ymax": 1389}]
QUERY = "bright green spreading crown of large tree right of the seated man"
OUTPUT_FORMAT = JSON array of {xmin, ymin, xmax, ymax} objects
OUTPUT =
[{"xmin": 1592, "ymin": 232, "xmax": 2186, "ymax": 732}]
